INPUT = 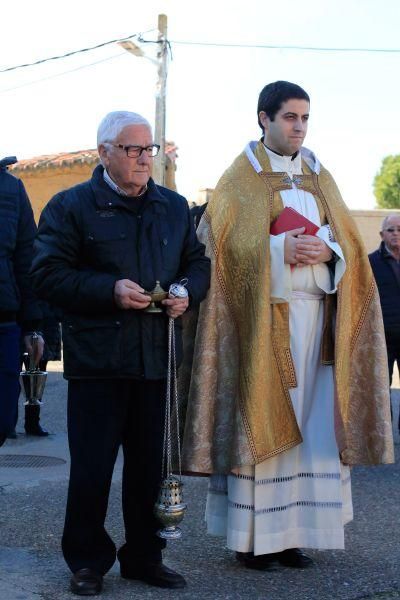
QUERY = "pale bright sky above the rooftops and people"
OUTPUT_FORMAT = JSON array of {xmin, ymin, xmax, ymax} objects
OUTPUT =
[{"xmin": 0, "ymin": 0, "xmax": 400, "ymax": 209}]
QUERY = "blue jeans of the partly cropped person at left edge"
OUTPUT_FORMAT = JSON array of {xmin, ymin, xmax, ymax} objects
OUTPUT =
[{"xmin": 0, "ymin": 323, "xmax": 21, "ymax": 438}]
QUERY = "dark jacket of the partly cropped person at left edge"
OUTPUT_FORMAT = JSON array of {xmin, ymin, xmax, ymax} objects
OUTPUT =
[{"xmin": 0, "ymin": 157, "xmax": 42, "ymax": 331}]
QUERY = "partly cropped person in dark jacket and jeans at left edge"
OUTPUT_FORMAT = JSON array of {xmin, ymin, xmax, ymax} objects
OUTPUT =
[{"xmin": 0, "ymin": 157, "xmax": 43, "ymax": 446}]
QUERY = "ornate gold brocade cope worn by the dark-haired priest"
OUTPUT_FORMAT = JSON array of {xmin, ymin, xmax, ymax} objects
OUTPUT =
[{"xmin": 183, "ymin": 142, "xmax": 393, "ymax": 473}]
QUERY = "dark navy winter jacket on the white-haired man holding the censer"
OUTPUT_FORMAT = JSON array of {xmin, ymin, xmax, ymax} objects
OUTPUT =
[{"xmin": 32, "ymin": 165, "xmax": 210, "ymax": 379}]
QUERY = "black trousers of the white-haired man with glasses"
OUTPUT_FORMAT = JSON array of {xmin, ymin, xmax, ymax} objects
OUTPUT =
[{"xmin": 62, "ymin": 379, "xmax": 166, "ymax": 575}]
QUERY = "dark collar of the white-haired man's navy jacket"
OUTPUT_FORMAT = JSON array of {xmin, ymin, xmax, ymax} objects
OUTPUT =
[{"xmin": 90, "ymin": 165, "xmax": 168, "ymax": 213}]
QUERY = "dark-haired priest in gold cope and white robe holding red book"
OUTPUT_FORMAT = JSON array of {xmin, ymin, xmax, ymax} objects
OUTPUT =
[{"xmin": 183, "ymin": 81, "xmax": 393, "ymax": 570}]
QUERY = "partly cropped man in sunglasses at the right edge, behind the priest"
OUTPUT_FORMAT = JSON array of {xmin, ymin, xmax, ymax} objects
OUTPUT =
[{"xmin": 369, "ymin": 214, "xmax": 400, "ymax": 431}]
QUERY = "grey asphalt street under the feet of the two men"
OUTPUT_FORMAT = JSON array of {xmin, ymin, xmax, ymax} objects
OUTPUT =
[{"xmin": 0, "ymin": 363, "xmax": 400, "ymax": 600}]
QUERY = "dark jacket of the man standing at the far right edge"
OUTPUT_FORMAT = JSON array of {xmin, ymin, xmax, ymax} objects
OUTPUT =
[{"xmin": 369, "ymin": 242, "xmax": 400, "ymax": 341}]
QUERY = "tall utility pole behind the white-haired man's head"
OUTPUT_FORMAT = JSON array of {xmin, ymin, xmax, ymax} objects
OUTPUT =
[{"xmin": 153, "ymin": 15, "xmax": 168, "ymax": 185}]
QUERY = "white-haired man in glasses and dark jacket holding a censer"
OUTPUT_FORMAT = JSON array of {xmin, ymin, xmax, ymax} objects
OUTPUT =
[{"xmin": 33, "ymin": 112, "xmax": 210, "ymax": 595}]
